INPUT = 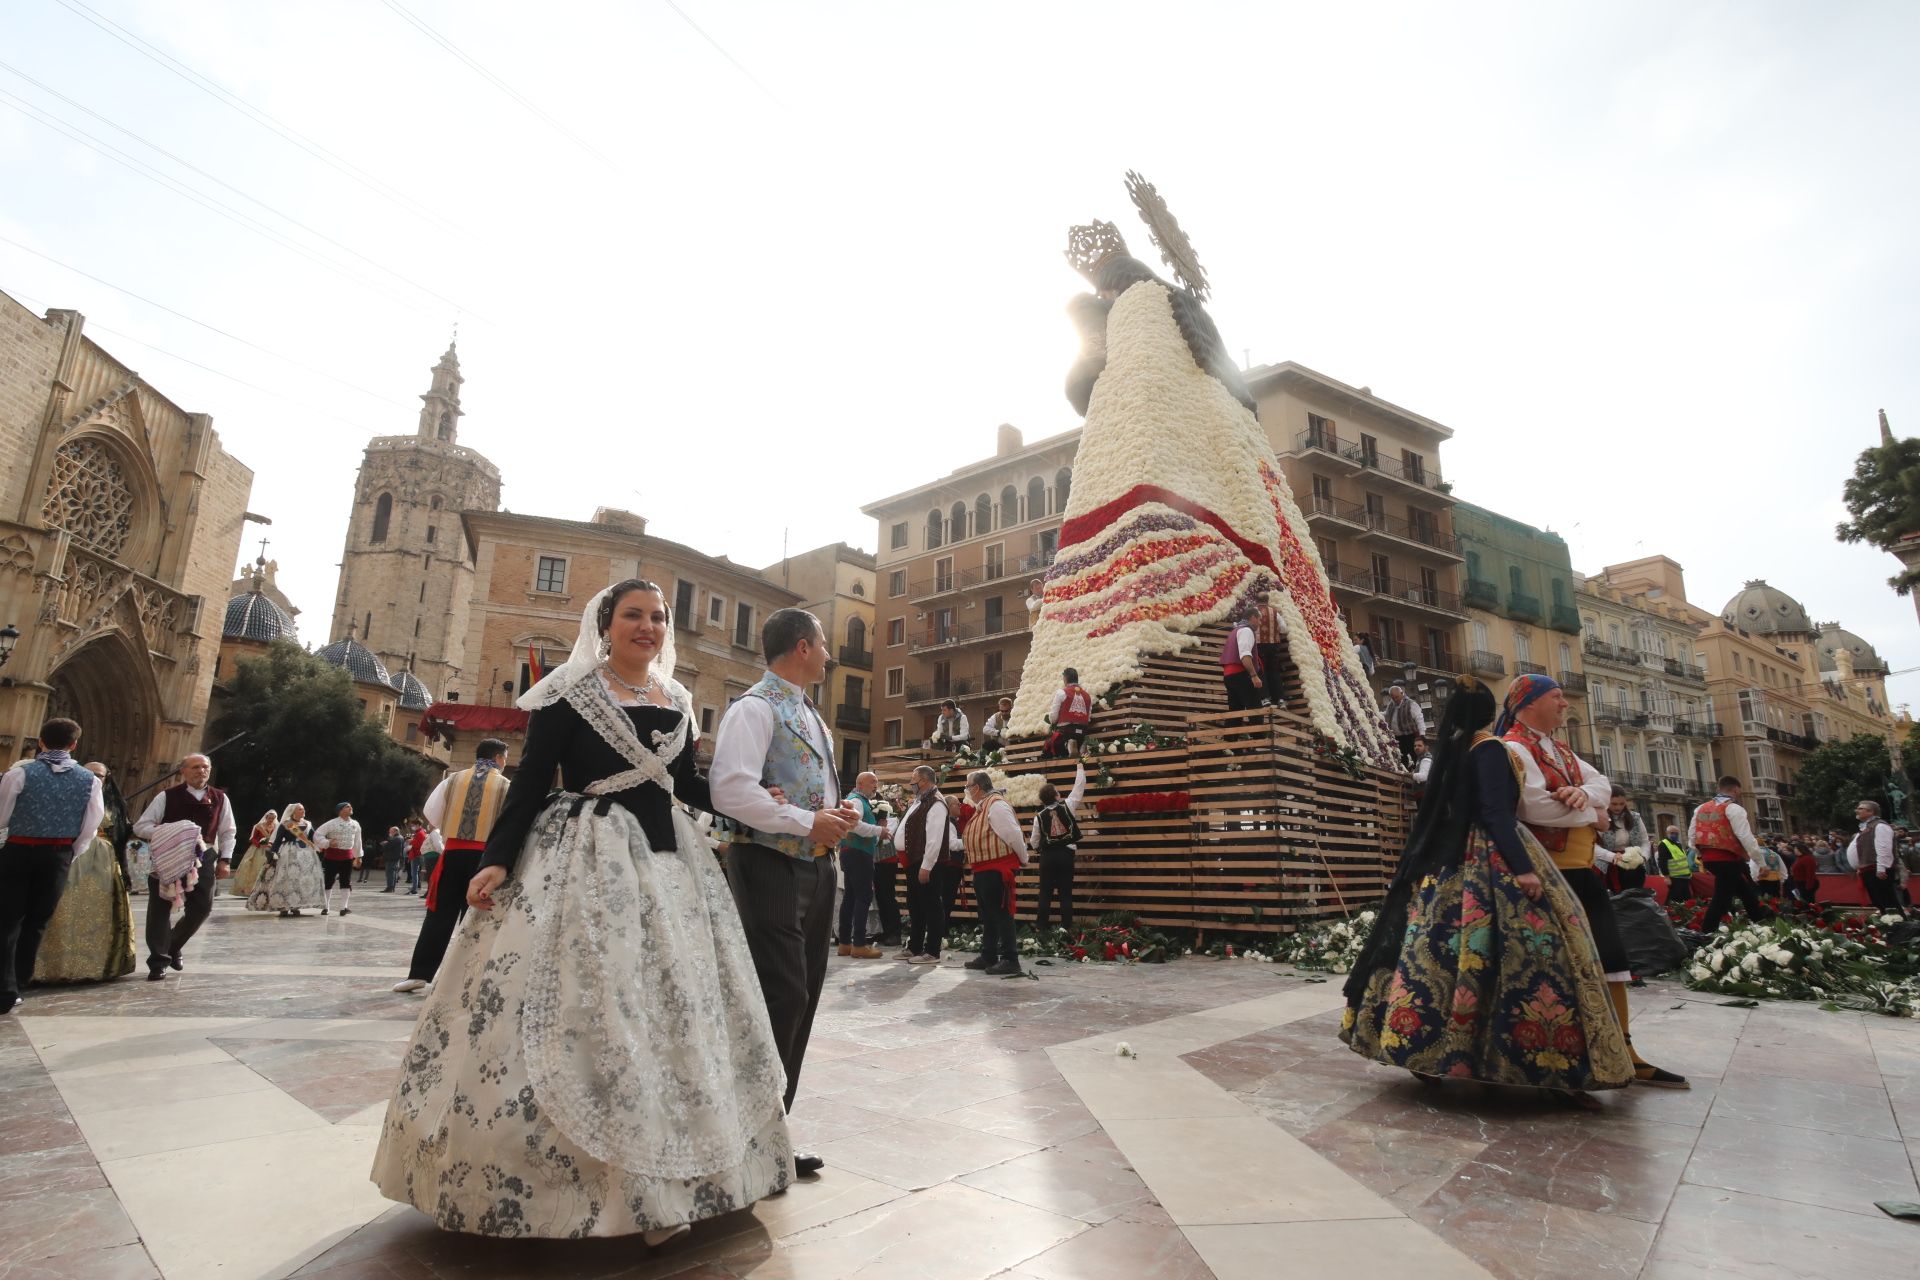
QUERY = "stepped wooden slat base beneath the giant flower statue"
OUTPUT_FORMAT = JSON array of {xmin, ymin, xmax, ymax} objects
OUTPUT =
[{"xmin": 874, "ymin": 628, "xmax": 1413, "ymax": 933}]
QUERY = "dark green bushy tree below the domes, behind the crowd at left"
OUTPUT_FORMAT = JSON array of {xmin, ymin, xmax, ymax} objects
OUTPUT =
[{"xmin": 213, "ymin": 641, "xmax": 438, "ymax": 842}]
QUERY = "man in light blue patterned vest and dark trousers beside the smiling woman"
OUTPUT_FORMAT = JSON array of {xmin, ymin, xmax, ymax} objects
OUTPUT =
[{"xmin": 707, "ymin": 608, "xmax": 860, "ymax": 1174}]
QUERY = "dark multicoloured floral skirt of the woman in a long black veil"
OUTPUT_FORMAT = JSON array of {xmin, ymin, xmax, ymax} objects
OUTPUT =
[{"xmin": 1340, "ymin": 829, "xmax": 1632, "ymax": 1090}]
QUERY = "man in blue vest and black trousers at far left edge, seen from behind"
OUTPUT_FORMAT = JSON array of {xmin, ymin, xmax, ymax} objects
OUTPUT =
[{"xmin": 0, "ymin": 720, "xmax": 106, "ymax": 1013}]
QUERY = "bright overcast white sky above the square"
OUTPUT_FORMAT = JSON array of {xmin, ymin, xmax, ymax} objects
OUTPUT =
[{"xmin": 0, "ymin": 0, "xmax": 1920, "ymax": 702}]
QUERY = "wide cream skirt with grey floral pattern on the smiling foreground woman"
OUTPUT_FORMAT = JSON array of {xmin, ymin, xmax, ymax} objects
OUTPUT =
[{"xmin": 372, "ymin": 794, "xmax": 793, "ymax": 1238}]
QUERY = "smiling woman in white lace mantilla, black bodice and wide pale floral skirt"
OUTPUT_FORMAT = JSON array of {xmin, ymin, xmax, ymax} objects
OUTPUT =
[{"xmin": 372, "ymin": 580, "xmax": 793, "ymax": 1245}]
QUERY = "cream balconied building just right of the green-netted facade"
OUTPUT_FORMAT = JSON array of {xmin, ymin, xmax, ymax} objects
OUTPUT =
[{"xmin": 1574, "ymin": 557, "xmax": 1722, "ymax": 829}]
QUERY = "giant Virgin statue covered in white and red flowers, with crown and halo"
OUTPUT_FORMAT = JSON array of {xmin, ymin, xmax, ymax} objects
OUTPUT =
[{"xmin": 1014, "ymin": 173, "xmax": 1400, "ymax": 770}]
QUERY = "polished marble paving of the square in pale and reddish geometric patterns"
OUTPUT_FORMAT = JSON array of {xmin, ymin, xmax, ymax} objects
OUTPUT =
[{"xmin": 0, "ymin": 890, "xmax": 1920, "ymax": 1280}]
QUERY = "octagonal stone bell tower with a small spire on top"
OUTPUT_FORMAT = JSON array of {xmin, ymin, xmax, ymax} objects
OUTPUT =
[{"xmin": 326, "ymin": 342, "xmax": 499, "ymax": 699}]
